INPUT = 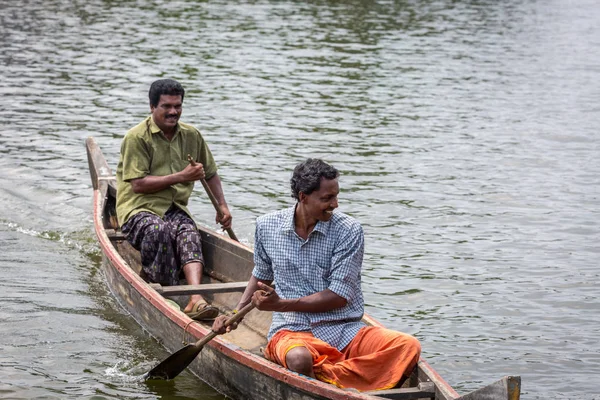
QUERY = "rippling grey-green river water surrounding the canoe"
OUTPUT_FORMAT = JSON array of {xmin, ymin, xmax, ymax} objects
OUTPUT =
[{"xmin": 0, "ymin": 0, "xmax": 600, "ymax": 399}]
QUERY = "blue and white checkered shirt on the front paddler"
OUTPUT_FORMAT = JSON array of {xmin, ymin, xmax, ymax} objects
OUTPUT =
[{"xmin": 252, "ymin": 206, "xmax": 365, "ymax": 350}]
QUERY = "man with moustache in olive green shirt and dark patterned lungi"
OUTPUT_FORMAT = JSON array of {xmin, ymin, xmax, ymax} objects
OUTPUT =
[{"xmin": 117, "ymin": 79, "xmax": 231, "ymax": 319}]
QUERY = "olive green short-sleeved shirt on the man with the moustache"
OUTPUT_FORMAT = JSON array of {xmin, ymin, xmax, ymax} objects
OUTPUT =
[{"xmin": 117, "ymin": 116, "xmax": 217, "ymax": 226}]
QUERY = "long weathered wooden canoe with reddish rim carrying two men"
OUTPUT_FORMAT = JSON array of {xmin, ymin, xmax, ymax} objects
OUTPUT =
[{"xmin": 86, "ymin": 137, "xmax": 521, "ymax": 400}]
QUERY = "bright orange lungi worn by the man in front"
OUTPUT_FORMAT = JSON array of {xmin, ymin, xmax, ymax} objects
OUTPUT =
[{"xmin": 265, "ymin": 326, "xmax": 421, "ymax": 391}]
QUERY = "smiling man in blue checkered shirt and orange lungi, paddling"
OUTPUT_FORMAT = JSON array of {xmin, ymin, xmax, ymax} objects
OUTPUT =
[{"xmin": 213, "ymin": 159, "xmax": 421, "ymax": 391}]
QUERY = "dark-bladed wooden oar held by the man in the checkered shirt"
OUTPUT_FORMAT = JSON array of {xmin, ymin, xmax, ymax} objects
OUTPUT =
[{"xmin": 144, "ymin": 302, "xmax": 254, "ymax": 379}]
